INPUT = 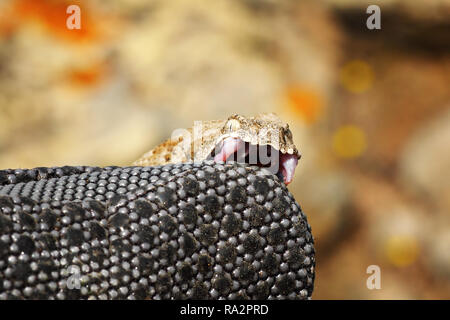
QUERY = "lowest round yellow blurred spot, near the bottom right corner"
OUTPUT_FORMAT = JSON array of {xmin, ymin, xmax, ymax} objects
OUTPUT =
[{"xmin": 385, "ymin": 235, "xmax": 419, "ymax": 267}]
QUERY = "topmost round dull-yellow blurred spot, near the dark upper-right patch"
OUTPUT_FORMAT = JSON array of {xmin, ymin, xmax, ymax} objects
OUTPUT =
[{"xmin": 340, "ymin": 60, "xmax": 374, "ymax": 93}]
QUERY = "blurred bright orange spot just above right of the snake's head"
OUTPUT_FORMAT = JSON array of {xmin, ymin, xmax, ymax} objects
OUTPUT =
[{"xmin": 286, "ymin": 86, "xmax": 323, "ymax": 124}]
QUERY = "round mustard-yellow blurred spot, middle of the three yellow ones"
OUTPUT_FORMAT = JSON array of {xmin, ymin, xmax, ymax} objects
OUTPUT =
[{"xmin": 333, "ymin": 125, "xmax": 367, "ymax": 158}]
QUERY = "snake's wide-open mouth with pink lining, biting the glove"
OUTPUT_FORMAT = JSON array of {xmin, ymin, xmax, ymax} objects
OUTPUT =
[{"xmin": 210, "ymin": 137, "xmax": 298, "ymax": 185}]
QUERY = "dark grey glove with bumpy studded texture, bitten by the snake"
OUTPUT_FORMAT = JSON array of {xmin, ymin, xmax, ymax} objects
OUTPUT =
[{"xmin": 0, "ymin": 162, "xmax": 315, "ymax": 299}]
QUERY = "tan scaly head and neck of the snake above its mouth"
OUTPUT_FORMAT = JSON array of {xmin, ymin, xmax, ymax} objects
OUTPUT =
[{"xmin": 133, "ymin": 113, "xmax": 300, "ymax": 166}]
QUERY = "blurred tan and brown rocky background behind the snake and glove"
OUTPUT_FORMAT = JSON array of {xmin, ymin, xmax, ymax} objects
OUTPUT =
[{"xmin": 0, "ymin": 0, "xmax": 450, "ymax": 299}]
